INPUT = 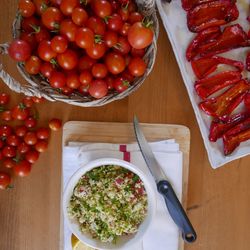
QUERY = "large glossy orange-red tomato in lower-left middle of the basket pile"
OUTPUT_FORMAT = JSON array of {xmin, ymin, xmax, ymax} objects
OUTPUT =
[{"xmin": 57, "ymin": 49, "xmax": 78, "ymax": 70}]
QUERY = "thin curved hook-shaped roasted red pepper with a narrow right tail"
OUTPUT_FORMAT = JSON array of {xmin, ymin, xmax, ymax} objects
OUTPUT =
[{"xmin": 191, "ymin": 56, "xmax": 244, "ymax": 79}]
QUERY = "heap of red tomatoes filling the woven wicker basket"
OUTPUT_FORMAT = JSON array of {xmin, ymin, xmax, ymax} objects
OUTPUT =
[{"xmin": 8, "ymin": 0, "xmax": 154, "ymax": 98}]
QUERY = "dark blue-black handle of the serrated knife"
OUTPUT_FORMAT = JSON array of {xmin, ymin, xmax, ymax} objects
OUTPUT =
[{"xmin": 157, "ymin": 180, "xmax": 197, "ymax": 243}]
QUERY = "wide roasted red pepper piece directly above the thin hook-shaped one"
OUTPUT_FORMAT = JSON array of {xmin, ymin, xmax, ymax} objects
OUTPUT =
[{"xmin": 198, "ymin": 24, "xmax": 250, "ymax": 56}]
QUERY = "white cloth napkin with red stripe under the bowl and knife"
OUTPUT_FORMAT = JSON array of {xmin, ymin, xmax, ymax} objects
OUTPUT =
[{"xmin": 63, "ymin": 139, "xmax": 182, "ymax": 250}]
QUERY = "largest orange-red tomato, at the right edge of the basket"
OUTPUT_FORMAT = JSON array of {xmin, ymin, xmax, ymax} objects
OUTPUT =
[{"xmin": 128, "ymin": 22, "xmax": 154, "ymax": 49}]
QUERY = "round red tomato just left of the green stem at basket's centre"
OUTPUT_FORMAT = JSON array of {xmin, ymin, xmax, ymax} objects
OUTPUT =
[{"xmin": 75, "ymin": 28, "xmax": 94, "ymax": 49}]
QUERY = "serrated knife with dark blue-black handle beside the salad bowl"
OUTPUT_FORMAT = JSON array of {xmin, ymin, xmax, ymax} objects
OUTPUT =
[{"xmin": 134, "ymin": 116, "xmax": 197, "ymax": 243}]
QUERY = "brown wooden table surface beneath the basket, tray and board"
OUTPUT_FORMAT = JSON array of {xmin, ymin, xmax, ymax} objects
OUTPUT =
[{"xmin": 0, "ymin": 0, "xmax": 250, "ymax": 250}]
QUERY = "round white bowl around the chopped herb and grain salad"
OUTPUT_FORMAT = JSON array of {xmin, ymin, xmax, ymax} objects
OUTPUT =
[{"xmin": 63, "ymin": 158, "xmax": 156, "ymax": 249}]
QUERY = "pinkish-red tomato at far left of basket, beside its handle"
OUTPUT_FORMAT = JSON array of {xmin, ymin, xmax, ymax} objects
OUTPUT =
[{"xmin": 8, "ymin": 39, "xmax": 31, "ymax": 62}]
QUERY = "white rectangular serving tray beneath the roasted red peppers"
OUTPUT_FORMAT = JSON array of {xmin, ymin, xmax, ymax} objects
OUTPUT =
[{"xmin": 156, "ymin": 0, "xmax": 250, "ymax": 168}]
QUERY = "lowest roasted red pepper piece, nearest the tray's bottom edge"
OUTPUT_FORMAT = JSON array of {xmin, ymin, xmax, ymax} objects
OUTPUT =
[{"xmin": 223, "ymin": 118, "xmax": 250, "ymax": 155}]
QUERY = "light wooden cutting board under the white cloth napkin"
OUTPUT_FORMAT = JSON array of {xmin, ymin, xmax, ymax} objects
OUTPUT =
[{"xmin": 61, "ymin": 121, "xmax": 190, "ymax": 250}]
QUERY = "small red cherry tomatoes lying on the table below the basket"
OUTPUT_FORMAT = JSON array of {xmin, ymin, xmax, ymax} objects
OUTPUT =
[{"xmin": 0, "ymin": 93, "xmax": 61, "ymax": 189}]
